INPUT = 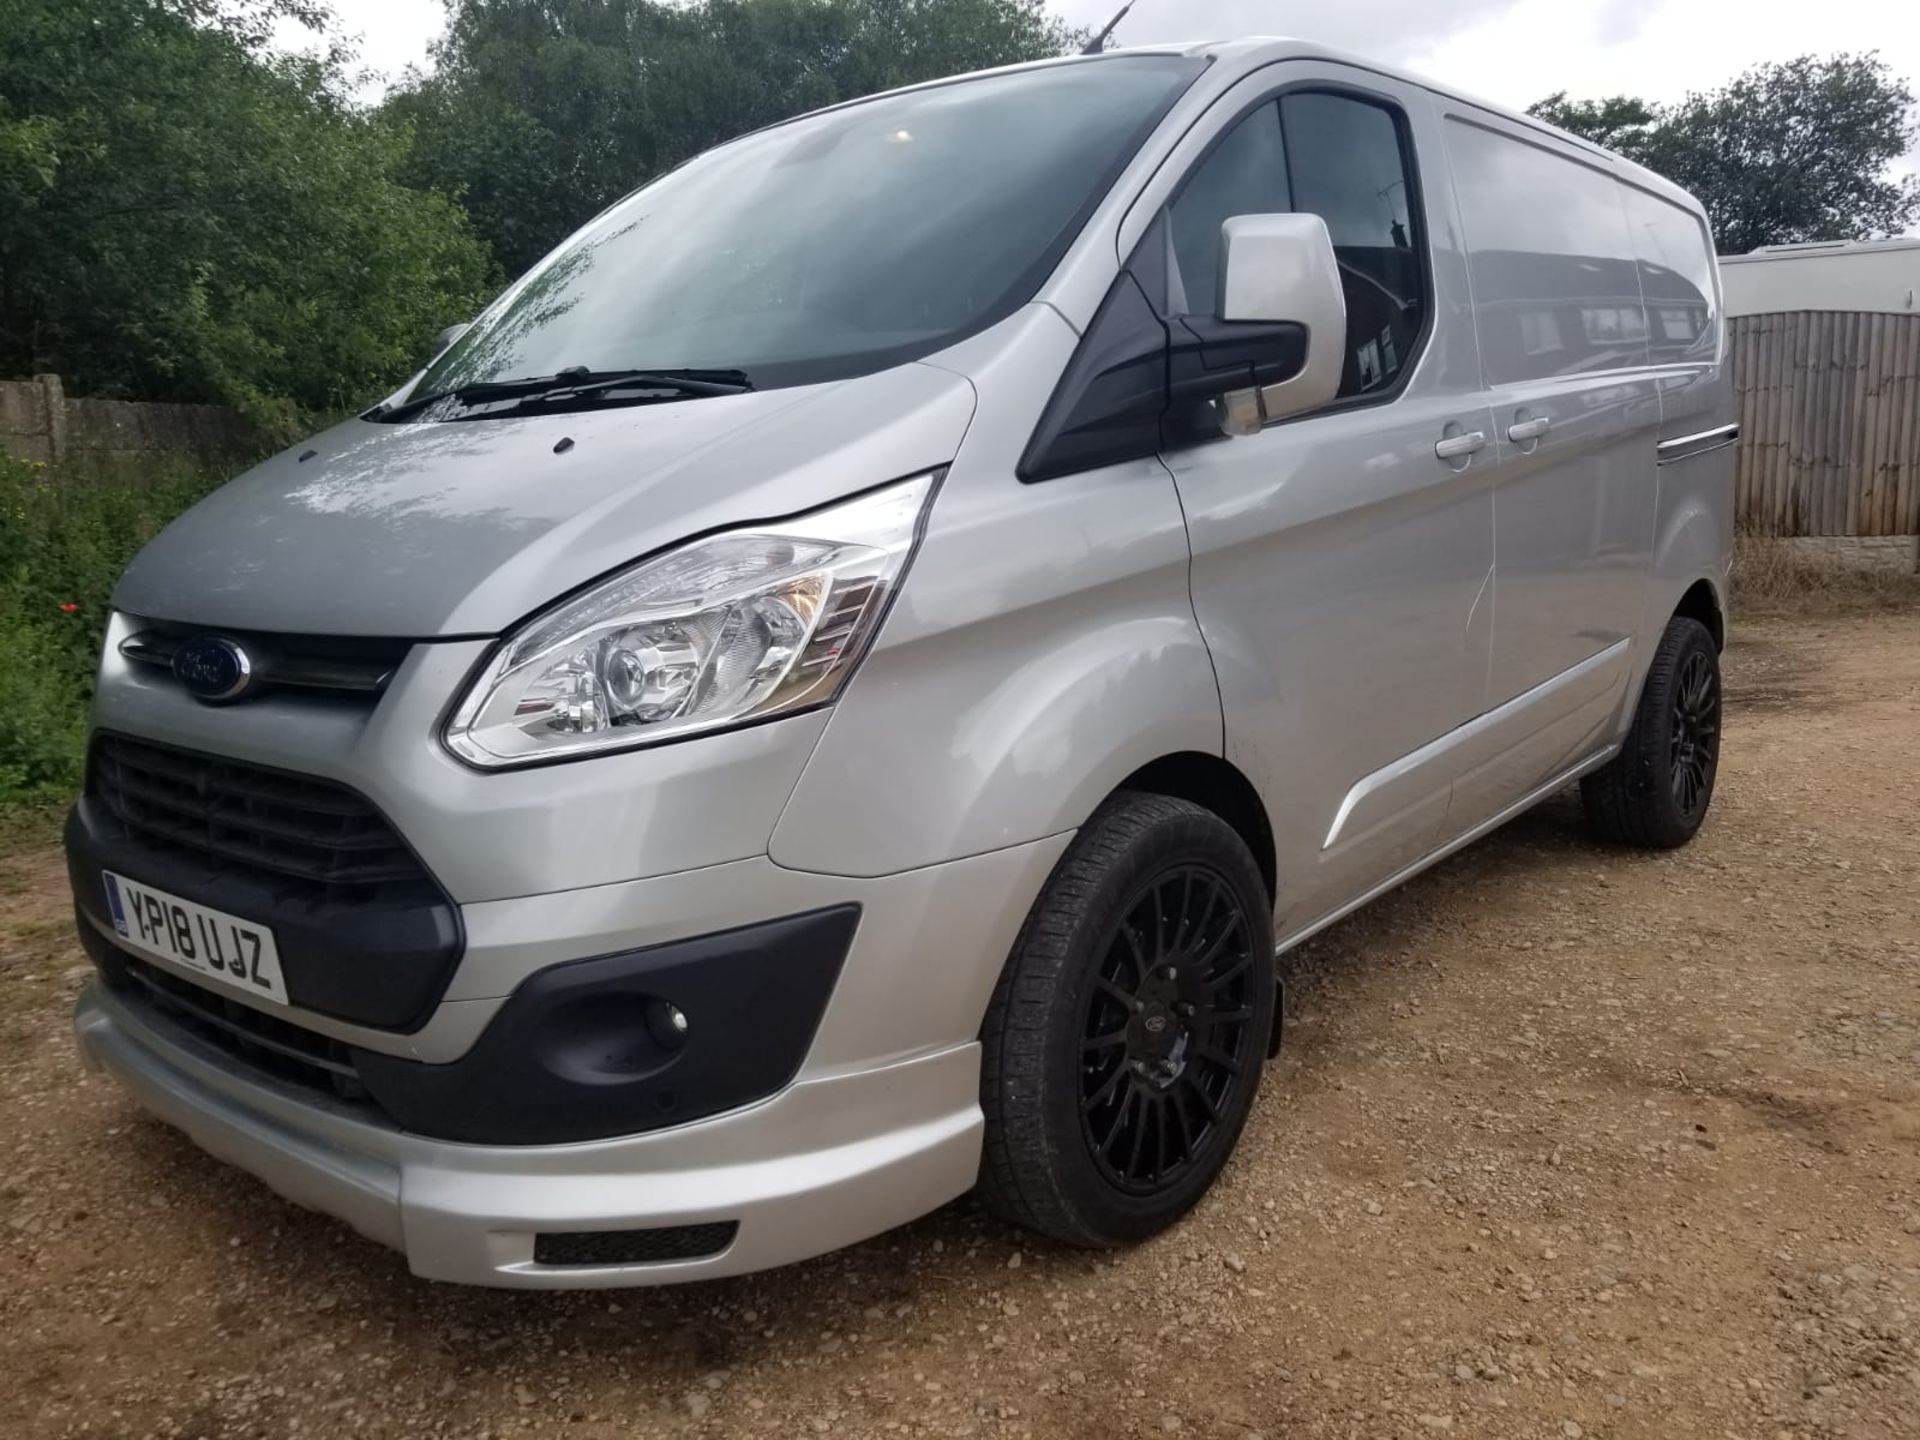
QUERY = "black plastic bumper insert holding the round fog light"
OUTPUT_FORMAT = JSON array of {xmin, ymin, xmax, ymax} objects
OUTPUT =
[{"xmin": 353, "ymin": 904, "xmax": 860, "ymax": 1144}]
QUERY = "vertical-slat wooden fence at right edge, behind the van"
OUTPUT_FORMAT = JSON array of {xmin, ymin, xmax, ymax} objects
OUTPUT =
[{"xmin": 1726, "ymin": 311, "xmax": 1920, "ymax": 536}]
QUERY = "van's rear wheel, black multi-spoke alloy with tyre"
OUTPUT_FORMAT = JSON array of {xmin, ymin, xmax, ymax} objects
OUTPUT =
[{"xmin": 1580, "ymin": 614, "xmax": 1720, "ymax": 851}]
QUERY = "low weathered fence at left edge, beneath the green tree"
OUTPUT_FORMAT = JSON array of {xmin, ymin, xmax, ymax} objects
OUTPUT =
[{"xmin": 0, "ymin": 374, "xmax": 253, "ymax": 463}]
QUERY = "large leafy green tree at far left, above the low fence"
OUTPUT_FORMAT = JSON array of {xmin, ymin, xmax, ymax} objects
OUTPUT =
[{"xmin": 0, "ymin": 0, "xmax": 490, "ymax": 428}]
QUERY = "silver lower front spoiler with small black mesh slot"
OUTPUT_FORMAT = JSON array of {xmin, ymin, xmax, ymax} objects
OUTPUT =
[{"xmin": 73, "ymin": 985, "xmax": 983, "ymax": 1288}]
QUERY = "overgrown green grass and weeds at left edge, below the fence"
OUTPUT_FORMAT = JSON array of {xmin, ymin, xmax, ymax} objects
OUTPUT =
[{"xmin": 0, "ymin": 453, "xmax": 227, "ymax": 829}]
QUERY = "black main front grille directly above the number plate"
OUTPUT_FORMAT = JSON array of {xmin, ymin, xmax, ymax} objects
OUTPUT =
[{"xmin": 86, "ymin": 735, "xmax": 440, "ymax": 900}]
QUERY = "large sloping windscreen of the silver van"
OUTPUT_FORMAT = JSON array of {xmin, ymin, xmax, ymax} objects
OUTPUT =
[{"xmin": 415, "ymin": 56, "xmax": 1204, "ymax": 396}]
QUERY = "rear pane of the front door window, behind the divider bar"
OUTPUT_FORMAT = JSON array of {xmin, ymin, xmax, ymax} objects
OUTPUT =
[{"xmin": 1281, "ymin": 90, "xmax": 1427, "ymax": 397}]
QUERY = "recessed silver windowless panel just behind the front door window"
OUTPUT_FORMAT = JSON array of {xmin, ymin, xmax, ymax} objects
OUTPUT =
[{"xmin": 1446, "ymin": 119, "xmax": 1651, "ymax": 384}]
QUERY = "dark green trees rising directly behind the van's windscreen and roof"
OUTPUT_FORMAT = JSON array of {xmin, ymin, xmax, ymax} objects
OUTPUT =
[{"xmin": 384, "ymin": 0, "xmax": 1075, "ymax": 275}]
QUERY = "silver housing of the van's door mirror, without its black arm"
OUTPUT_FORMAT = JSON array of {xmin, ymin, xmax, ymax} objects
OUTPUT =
[{"xmin": 1215, "ymin": 215, "xmax": 1346, "ymax": 434}]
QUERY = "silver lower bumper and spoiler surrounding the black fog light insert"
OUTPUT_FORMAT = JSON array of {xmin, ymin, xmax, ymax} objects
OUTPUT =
[{"xmin": 75, "ymin": 835, "xmax": 1069, "ymax": 1288}]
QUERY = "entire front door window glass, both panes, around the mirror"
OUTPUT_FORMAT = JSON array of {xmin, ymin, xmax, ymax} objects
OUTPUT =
[{"xmin": 1167, "ymin": 90, "xmax": 1427, "ymax": 399}]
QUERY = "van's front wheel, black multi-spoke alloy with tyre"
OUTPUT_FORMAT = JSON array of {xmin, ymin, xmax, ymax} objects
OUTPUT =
[{"xmin": 979, "ymin": 791, "xmax": 1279, "ymax": 1248}]
